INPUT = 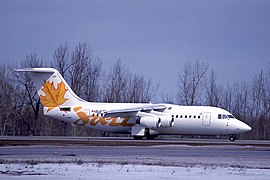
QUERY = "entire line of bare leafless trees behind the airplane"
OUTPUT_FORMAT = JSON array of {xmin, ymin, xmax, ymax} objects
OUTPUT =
[{"xmin": 0, "ymin": 43, "xmax": 270, "ymax": 139}]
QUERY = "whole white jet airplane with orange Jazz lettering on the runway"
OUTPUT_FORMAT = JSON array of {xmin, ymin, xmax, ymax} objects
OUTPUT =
[{"xmin": 14, "ymin": 68, "xmax": 251, "ymax": 141}]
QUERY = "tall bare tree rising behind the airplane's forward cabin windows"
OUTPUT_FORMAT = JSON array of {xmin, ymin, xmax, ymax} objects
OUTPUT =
[{"xmin": 177, "ymin": 60, "xmax": 208, "ymax": 106}]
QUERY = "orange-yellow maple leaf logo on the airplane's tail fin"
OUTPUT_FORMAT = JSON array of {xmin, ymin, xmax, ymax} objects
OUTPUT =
[{"xmin": 40, "ymin": 81, "xmax": 68, "ymax": 111}]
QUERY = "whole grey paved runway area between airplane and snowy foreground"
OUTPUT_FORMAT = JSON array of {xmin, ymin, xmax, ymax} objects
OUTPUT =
[{"xmin": 0, "ymin": 137, "xmax": 270, "ymax": 169}]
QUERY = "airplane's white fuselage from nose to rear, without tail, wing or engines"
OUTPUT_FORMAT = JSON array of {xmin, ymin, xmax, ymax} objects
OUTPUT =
[{"xmin": 45, "ymin": 102, "xmax": 251, "ymax": 135}]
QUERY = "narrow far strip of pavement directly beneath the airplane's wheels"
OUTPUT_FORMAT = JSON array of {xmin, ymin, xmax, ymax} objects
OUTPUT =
[{"xmin": 0, "ymin": 136, "xmax": 270, "ymax": 147}]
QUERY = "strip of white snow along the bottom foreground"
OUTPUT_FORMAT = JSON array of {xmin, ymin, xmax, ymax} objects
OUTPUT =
[{"xmin": 0, "ymin": 162, "xmax": 270, "ymax": 180}]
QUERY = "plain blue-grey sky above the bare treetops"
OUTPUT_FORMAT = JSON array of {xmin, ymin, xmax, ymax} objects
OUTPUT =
[{"xmin": 0, "ymin": 0, "xmax": 270, "ymax": 97}]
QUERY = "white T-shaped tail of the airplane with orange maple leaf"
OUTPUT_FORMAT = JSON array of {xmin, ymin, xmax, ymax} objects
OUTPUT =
[{"xmin": 15, "ymin": 68, "xmax": 83, "ymax": 112}]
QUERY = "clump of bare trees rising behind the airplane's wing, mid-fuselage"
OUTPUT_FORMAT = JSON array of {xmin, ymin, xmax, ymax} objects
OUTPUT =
[{"xmin": 103, "ymin": 60, "xmax": 158, "ymax": 103}]
